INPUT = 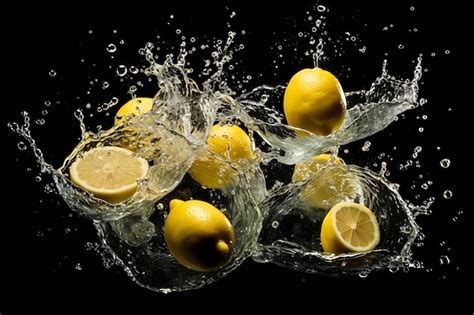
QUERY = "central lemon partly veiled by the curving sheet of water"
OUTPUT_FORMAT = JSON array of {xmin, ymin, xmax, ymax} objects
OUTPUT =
[{"xmin": 188, "ymin": 125, "xmax": 253, "ymax": 189}]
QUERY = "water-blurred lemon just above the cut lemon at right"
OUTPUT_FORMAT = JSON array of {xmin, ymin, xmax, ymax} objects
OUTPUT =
[{"xmin": 292, "ymin": 154, "xmax": 357, "ymax": 209}]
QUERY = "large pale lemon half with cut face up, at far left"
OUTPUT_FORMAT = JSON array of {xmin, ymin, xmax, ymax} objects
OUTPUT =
[{"xmin": 69, "ymin": 146, "xmax": 148, "ymax": 203}]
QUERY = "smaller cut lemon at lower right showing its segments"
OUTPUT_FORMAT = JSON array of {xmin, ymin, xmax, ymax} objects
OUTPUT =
[{"xmin": 321, "ymin": 202, "xmax": 380, "ymax": 254}]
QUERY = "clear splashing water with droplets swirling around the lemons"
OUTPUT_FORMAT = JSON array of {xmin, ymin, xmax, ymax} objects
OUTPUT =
[{"xmin": 9, "ymin": 6, "xmax": 452, "ymax": 293}]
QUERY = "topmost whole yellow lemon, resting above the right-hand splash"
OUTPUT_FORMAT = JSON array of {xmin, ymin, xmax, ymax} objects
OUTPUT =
[{"xmin": 283, "ymin": 68, "xmax": 346, "ymax": 136}]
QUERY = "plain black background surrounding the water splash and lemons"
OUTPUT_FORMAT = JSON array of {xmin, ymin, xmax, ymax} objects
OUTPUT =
[{"xmin": 0, "ymin": 1, "xmax": 473, "ymax": 314}]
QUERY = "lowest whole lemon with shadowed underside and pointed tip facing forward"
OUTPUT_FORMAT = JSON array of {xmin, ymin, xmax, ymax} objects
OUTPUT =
[{"xmin": 164, "ymin": 199, "xmax": 234, "ymax": 271}]
